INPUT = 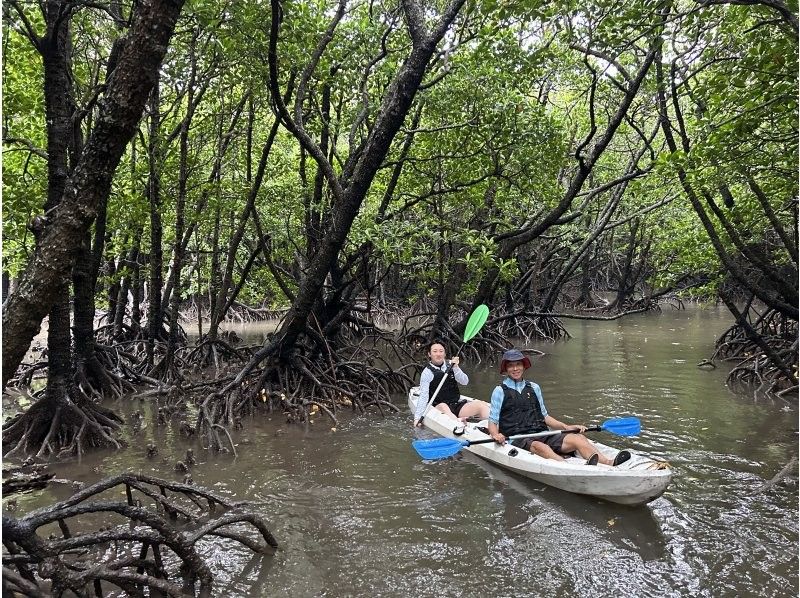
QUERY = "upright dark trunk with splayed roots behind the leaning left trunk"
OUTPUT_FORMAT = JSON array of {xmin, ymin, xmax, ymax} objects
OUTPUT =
[{"xmin": 3, "ymin": 0, "xmax": 120, "ymax": 455}]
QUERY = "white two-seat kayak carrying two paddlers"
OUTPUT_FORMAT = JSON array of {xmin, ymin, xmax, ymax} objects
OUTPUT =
[{"xmin": 408, "ymin": 386, "xmax": 672, "ymax": 505}]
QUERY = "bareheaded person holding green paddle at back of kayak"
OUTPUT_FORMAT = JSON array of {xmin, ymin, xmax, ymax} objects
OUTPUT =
[{"xmin": 414, "ymin": 341, "xmax": 489, "ymax": 426}]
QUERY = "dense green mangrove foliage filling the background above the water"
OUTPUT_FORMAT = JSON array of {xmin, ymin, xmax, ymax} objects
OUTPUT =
[{"xmin": 3, "ymin": 0, "xmax": 798, "ymax": 404}]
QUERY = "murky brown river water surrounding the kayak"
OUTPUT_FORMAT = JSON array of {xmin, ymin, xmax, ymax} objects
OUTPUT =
[{"xmin": 3, "ymin": 306, "xmax": 798, "ymax": 598}]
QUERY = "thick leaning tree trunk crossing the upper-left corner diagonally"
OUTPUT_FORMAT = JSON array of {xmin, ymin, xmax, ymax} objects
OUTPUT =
[{"xmin": 2, "ymin": 0, "xmax": 183, "ymax": 388}]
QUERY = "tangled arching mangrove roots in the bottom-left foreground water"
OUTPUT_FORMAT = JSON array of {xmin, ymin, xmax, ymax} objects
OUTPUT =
[{"xmin": 3, "ymin": 473, "xmax": 278, "ymax": 596}]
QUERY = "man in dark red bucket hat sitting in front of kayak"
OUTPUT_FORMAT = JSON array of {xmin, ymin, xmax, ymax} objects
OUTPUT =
[{"xmin": 489, "ymin": 349, "xmax": 631, "ymax": 465}]
